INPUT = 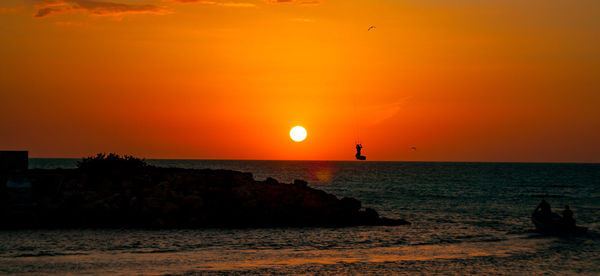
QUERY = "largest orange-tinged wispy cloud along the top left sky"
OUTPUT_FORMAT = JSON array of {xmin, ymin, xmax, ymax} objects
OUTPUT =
[{"xmin": 35, "ymin": 0, "xmax": 168, "ymax": 17}]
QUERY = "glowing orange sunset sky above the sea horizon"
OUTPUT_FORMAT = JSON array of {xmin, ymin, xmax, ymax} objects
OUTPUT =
[{"xmin": 0, "ymin": 0, "xmax": 600, "ymax": 162}]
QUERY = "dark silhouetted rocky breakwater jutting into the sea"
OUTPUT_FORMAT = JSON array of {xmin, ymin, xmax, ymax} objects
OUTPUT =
[{"xmin": 2, "ymin": 155, "xmax": 409, "ymax": 228}]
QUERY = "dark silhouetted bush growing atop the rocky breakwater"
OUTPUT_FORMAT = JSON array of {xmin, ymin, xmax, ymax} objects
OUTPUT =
[{"xmin": 77, "ymin": 153, "xmax": 150, "ymax": 171}]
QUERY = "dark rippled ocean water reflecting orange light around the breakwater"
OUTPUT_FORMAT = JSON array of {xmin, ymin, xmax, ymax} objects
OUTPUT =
[{"xmin": 0, "ymin": 159, "xmax": 600, "ymax": 275}]
